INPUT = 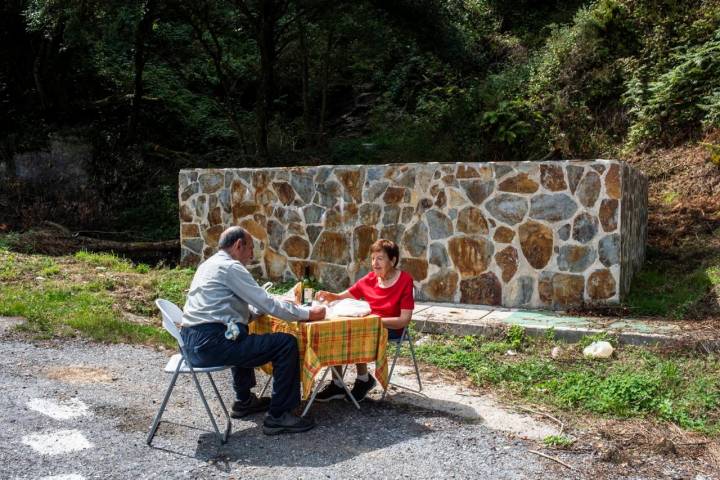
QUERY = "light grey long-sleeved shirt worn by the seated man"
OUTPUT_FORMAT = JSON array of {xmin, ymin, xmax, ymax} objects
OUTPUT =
[{"xmin": 182, "ymin": 250, "xmax": 310, "ymax": 327}]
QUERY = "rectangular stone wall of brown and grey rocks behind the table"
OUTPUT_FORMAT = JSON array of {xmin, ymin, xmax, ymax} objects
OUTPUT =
[{"xmin": 179, "ymin": 160, "xmax": 647, "ymax": 308}]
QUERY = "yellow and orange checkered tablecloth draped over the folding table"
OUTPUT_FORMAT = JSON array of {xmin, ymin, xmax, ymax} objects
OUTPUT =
[{"xmin": 249, "ymin": 315, "xmax": 388, "ymax": 399}]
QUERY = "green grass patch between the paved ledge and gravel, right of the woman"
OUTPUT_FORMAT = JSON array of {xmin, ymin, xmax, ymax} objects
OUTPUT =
[{"xmin": 408, "ymin": 331, "xmax": 720, "ymax": 436}]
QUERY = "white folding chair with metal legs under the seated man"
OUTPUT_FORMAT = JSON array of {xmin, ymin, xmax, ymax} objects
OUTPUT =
[{"xmin": 147, "ymin": 298, "xmax": 231, "ymax": 445}]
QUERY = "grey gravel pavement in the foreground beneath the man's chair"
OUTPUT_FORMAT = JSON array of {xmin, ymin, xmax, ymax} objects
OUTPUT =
[{"xmin": 0, "ymin": 340, "xmax": 581, "ymax": 479}]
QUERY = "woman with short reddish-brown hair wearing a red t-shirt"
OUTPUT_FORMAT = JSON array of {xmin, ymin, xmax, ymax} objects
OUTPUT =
[{"xmin": 315, "ymin": 239, "xmax": 415, "ymax": 402}]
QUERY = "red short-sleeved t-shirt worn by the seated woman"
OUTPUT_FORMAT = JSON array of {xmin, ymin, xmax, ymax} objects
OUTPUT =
[{"xmin": 348, "ymin": 271, "xmax": 415, "ymax": 318}]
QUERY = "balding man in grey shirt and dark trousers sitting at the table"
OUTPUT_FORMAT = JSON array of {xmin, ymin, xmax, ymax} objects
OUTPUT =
[{"xmin": 181, "ymin": 227, "xmax": 325, "ymax": 435}]
